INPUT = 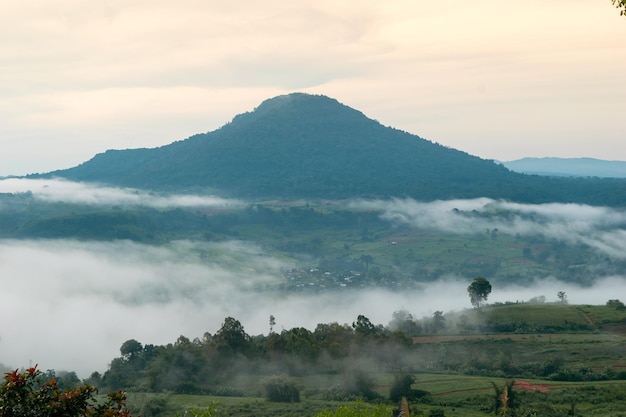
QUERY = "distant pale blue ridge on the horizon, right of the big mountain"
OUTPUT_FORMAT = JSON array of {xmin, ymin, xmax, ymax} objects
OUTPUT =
[{"xmin": 502, "ymin": 158, "xmax": 626, "ymax": 178}]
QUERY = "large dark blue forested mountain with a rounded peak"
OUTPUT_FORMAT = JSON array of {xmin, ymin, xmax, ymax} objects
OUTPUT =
[{"xmin": 41, "ymin": 93, "xmax": 626, "ymax": 205}]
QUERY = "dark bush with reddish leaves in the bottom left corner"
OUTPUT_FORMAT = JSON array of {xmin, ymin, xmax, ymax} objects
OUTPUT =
[{"xmin": 0, "ymin": 367, "xmax": 130, "ymax": 417}]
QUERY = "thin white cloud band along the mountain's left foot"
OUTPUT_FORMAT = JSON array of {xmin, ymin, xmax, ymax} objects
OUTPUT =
[{"xmin": 0, "ymin": 178, "xmax": 242, "ymax": 208}]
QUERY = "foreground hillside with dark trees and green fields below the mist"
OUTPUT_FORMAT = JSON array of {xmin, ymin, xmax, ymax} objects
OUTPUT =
[{"xmin": 74, "ymin": 300, "xmax": 626, "ymax": 416}]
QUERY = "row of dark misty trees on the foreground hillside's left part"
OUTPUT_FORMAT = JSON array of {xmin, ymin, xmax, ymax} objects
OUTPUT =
[{"xmin": 87, "ymin": 315, "xmax": 412, "ymax": 396}]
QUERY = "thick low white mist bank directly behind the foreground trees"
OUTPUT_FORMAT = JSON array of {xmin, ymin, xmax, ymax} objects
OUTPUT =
[{"xmin": 0, "ymin": 240, "xmax": 626, "ymax": 377}]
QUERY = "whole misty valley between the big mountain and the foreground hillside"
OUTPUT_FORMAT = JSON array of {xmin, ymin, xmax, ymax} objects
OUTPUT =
[{"xmin": 0, "ymin": 179, "xmax": 626, "ymax": 377}]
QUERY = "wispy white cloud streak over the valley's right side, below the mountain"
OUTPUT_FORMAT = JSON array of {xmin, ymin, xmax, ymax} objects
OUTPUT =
[{"xmin": 352, "ymin": 198, "xmax": 626, "ymax": 259}]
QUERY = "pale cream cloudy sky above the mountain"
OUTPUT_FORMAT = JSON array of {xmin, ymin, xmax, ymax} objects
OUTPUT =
[{"xmin": 0, "ymin": 0, "xmax": 626, "ymax": 175}]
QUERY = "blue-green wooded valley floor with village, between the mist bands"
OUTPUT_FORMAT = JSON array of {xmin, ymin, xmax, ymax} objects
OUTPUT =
[{"xmin": 0, "ymin": 194, "xmax": 626, "ymax": 291}]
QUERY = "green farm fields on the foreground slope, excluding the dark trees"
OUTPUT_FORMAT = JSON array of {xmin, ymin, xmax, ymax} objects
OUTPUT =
[{"xmin": 114, "ymin": 304, "xmax": 626, "ymax": 417}]
